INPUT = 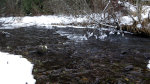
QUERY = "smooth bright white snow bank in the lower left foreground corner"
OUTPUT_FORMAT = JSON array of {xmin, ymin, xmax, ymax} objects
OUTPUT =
[{"xmin": 0, "ymin": 52, "xmax": 35, "ymax": 84}]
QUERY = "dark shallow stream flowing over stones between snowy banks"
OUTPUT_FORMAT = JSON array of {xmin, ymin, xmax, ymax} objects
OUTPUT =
[{"xmin": 0, "ymin": 27, "xmax": 150, "ymax": 84}]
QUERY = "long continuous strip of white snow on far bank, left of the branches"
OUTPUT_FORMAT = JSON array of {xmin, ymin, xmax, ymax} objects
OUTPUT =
[{"xmin": 0, "ymin": 13, "xmax": 113, "ymax": 29}]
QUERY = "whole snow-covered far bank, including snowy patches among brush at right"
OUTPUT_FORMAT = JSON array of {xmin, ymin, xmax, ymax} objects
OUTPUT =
[{"xmin": 0, "ymin": 1, "xmax": 150, "ymax": 29}]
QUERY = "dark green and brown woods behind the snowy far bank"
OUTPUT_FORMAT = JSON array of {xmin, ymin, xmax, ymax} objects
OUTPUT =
[{"xmin": 0, "ymin": 0, "xmax": 150, "ymax": 16}]
